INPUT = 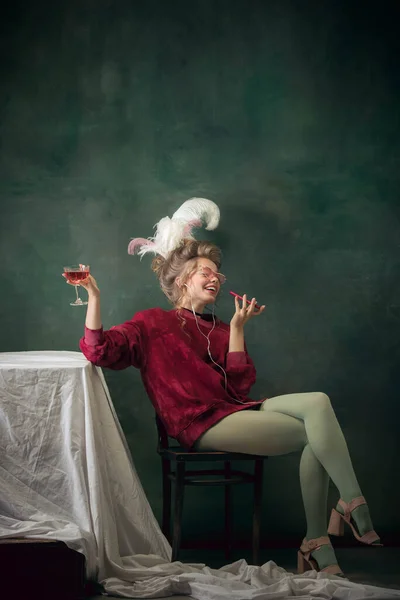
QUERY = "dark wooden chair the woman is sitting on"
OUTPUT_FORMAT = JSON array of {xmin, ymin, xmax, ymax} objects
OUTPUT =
[{"xmin": 156, "ymin": 416, "xmax": 268, "ymax": 565}]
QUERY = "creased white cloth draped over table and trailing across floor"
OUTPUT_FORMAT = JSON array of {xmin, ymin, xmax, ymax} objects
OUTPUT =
[{"xmin": 0, "ymin": 352, "xmax": 400, "ymax": 600}]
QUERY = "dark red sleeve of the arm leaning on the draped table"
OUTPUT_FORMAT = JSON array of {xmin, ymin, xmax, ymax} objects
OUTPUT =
[{"xmin": 79, "ymin": 319, "xmax": 146, "ymax": 370}]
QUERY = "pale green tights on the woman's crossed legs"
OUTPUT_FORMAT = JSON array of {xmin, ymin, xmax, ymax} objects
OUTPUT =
[{"xmin": 196, "ymin": 392, "xmax": 373, "ymax": 569}]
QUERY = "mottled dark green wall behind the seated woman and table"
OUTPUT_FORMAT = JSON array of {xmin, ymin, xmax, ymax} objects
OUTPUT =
[{"xmin": 0, "ymin": 0, "xmax": 400, "ymax": 538}]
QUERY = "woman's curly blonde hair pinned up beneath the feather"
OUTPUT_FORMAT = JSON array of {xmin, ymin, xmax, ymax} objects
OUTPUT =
[{"xmin": 151, "ymin": 239, "xmax": 221, "ymax": 308}]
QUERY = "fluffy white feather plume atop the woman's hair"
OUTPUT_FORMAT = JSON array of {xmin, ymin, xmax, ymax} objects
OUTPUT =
[{"xmin": 128, "ymin": 198, "xmax": 220, "ymax": 258}]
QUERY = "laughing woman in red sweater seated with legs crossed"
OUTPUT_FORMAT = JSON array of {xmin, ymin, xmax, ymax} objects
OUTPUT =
[{"xmin": 70, "ymin": 199, "xmax": 379, "ymax": 575}]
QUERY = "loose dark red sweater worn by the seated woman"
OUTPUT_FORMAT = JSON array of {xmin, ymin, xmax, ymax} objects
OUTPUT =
[{"xmin": 80, "ymin": 308, "xmax": 262, "ymax": 448}]
